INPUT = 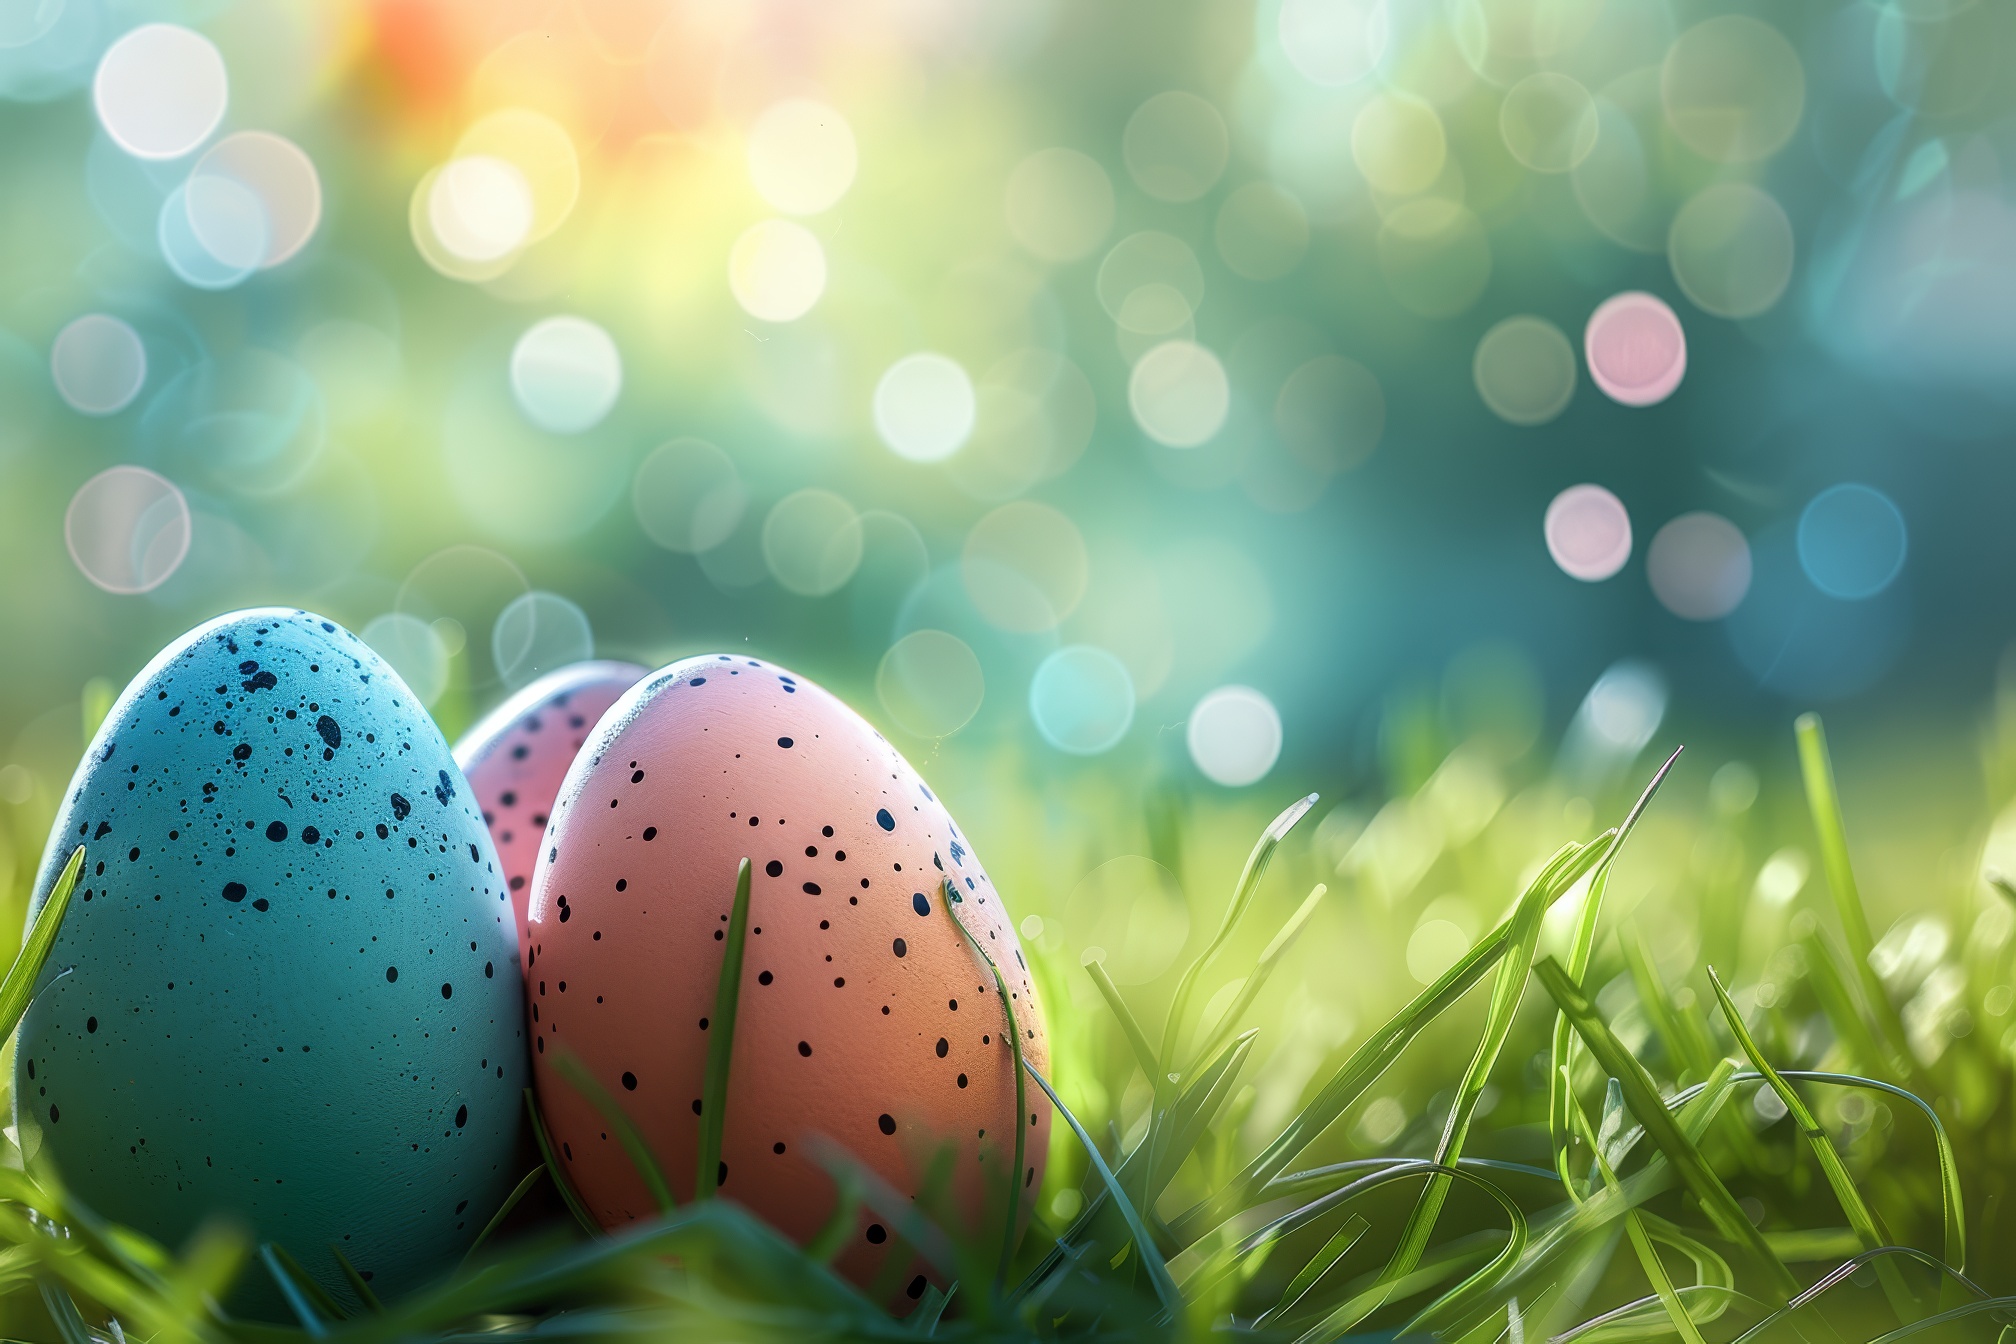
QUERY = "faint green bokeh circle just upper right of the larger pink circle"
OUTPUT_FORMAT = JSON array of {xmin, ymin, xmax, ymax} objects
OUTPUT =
[{"xmin": 1667, "ymin": 181, "xmax": 1792, "ymax": 318}]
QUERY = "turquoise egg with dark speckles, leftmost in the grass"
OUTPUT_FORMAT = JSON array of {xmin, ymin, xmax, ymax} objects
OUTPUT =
[{"xmin": 14, "ymin": 609, "xmax": 526, "ymax": 1314}]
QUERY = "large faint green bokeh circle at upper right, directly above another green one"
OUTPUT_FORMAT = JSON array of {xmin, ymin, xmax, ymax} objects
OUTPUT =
[{"xmin": 1659, "ymin": 14, "xmax": 1806, "ymax": 163}]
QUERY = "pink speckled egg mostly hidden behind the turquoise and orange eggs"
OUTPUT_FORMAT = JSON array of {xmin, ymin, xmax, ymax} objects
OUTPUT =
[{"xmin": 456, "ymin": 661, "xmax": 645, "ymax": 955}]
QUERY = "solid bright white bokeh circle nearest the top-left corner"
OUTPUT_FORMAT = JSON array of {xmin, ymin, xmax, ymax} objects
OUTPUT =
[{"xmin": 91, "ymin": 24, "xmax": 230, "ymax": 159}]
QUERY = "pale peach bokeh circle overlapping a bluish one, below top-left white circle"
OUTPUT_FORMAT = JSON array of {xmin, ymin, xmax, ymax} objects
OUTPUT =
[{"xmin": 185, "ymin": 131, "xmax": 323, "ymax": 270}]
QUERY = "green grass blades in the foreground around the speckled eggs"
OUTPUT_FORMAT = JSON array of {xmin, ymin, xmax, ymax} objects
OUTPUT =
[{"xmin": 0, "ymin": 715, "xmax": 2016, "ymax": 1344}]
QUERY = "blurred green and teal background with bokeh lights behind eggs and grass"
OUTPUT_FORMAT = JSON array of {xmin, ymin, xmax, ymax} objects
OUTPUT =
[{"xmin": 0, "ymin": 0, "xmax": 2016, "ymax": 1289}]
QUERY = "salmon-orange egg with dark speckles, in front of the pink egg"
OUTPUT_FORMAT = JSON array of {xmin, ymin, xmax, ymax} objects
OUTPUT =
[{"xmin": 526, "ymin": 655, "xmax": 1050, "ymax": 1298}]
